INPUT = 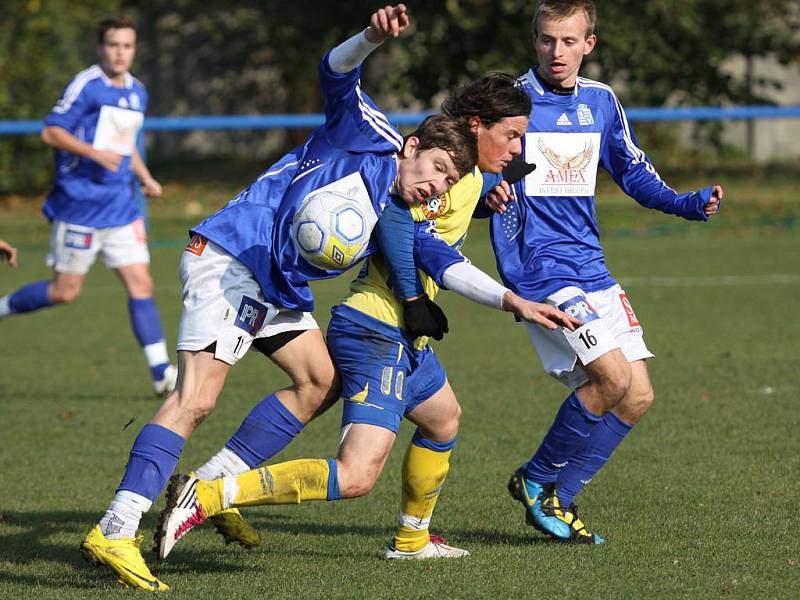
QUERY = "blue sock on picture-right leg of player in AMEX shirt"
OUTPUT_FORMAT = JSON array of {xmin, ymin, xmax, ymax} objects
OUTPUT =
[{"xmin": 556, "ymin": 412, "xmax": 633, "ymax": 506}]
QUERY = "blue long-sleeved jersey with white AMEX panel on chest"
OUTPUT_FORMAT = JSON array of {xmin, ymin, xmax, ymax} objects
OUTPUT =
[{"xmin": 491, "ymin": 69, "xmax": 712, "ymax": 301}]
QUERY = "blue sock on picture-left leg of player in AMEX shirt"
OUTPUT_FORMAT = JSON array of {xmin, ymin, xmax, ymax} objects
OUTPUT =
[{"xmin": 525, "ymin": 392, "xmax": 603, "ymax": 484}]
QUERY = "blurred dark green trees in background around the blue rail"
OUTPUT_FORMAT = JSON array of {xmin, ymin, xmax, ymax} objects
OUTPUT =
[{"xmin": 0, "ymin": 0, "xmax": 800, "ymax": 191}]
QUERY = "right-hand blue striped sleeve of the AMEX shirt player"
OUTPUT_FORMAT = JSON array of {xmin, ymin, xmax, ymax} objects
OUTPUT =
[{"xmin": 600, "ymin": 93, "xmax": 710, "ymax": 221}]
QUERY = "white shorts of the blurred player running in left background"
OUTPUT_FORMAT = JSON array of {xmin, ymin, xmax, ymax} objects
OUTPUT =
[{"xmin": 47, "ymin": 217, "xmax": 150, "ymax": 275}]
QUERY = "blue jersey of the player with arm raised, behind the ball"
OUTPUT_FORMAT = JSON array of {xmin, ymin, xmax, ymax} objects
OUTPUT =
[{"xmin": 192, "ymin": 55, "xmax": 403, "ymax": 311}]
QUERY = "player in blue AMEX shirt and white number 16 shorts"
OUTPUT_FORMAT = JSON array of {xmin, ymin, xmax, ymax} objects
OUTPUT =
[{"xmin": 488, "ymin": 0, "xmax": 723, "ymax": 544}]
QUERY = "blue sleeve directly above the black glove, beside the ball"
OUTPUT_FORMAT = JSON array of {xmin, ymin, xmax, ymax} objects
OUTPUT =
[{"xmin": 375, "ymin": 196, "xmax": 423, "ymax": 300}]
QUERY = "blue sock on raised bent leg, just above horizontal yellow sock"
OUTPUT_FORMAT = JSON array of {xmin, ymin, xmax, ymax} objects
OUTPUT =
[{"xmin": 225, "ymin": 394, "xmax": 305, "ymax": 468}]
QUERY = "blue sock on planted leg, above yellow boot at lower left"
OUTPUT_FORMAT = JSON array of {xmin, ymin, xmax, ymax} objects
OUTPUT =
[{"xmin": 117, "ymin": 423, "xmax": 186, "ymax": 502}]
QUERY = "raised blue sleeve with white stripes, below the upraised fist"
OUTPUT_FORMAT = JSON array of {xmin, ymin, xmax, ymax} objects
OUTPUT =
[{"xmin": 319, "ymin": 54, "xmax": 403, "ymax": 152}]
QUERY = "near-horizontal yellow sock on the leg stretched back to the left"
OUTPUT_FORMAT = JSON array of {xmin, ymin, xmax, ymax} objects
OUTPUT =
[{"xmin": 231, "ymin": 459, "xmax": 330, "ymax": 507}]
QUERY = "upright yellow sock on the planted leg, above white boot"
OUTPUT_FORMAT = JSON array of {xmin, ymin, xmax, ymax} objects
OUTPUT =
[{"xmin": 392, "ymin": 440, "xmax": 452, "ymax": 552}]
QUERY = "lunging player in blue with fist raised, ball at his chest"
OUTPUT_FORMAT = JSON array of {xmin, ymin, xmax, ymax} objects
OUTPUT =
[{"xmin": 81, "ymin": 5, "xmax": 477, "ymax": 590}]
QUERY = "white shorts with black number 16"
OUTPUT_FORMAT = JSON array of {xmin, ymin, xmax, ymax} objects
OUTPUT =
[{"xmin": 525, "ymin": 285, "xmax": 653, "ymax": 389}]
